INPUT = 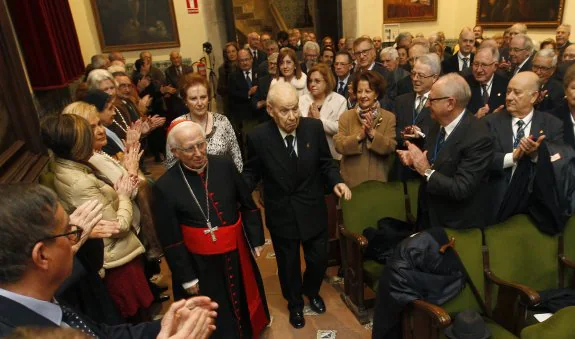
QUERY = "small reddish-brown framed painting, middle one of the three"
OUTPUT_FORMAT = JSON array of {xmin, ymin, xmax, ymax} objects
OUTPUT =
[{"xmin": 383, "ymin": 0, "xmax": 439, "ymax": 24}]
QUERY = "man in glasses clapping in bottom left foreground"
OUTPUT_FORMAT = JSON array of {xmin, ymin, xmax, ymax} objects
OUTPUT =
[{"xmin": 0, "ymin": 185, "xmax": 217, "ymax": 339}]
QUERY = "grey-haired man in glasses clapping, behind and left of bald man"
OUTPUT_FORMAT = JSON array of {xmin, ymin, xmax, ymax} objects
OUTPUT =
[{"xmin": 465, "ymin": 46, "xmax": 509, "ymax": 118}]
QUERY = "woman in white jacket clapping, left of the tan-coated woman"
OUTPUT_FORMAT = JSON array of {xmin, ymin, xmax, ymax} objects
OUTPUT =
[{"xmin": 299, "ymin": 64, "xmax": 347, "ymax": 160}]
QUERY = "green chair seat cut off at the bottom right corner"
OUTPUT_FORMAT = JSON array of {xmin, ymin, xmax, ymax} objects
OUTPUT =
[{"xmin": 521, "ymin": 306, "xmax": 575, "ymax": 339}]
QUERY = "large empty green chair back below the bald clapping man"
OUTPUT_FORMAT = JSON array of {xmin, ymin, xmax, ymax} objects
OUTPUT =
[{"xmin": 484, "ymin": 214, "xmax": 559, "ymax": 297}]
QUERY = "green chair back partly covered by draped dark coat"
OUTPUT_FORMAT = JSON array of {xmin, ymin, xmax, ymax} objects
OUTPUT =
[{"xmin": 441, "ymin": 228, "xmax": 485, "ymax": 315}]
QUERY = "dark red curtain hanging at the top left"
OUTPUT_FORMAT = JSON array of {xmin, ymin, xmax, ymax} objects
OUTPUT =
[{"xmin": 7, "ymin": 0, "xmax": 84, "ymax": 90}]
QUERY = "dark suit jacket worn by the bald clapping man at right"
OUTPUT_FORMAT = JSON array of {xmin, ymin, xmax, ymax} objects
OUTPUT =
[{"xmin": 484, "ymin": 110, "xmax": 563, "ymax": 222}]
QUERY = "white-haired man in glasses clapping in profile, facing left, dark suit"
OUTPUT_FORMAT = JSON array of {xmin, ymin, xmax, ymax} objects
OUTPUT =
[{"xmin": 397, "ymin": 74, "xmax": 493, "ymax": 229}]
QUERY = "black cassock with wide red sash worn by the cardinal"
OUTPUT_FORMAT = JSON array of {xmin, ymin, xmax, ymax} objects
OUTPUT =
[{"xmin": 154, "ymin": 155, "xmax": 269, "ymax": 338}]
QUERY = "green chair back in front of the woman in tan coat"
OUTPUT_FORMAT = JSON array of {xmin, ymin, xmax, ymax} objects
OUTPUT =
[{"xmin": 342, "ymin": 181, "xmax": 406, "ymax": 234}]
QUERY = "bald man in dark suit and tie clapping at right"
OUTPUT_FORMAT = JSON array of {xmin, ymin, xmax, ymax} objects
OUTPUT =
[{"xmin": 484, "ymin": 71, "xmax": 563, "ymax": 223}]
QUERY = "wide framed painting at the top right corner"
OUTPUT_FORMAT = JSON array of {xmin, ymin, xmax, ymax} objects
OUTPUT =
[{"xmin": 477, "ymin": 0, "xmax": 565, "ymax": 28}]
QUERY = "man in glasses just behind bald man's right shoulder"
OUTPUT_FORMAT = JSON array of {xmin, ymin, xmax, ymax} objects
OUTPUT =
[{"xmin": 531, "ymin": 49, "xmax": 565, "ymax": 112}]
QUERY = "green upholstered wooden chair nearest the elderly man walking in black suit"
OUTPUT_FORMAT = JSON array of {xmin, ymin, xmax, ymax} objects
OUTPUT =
[{"xmin": 340, "ymin": 181, "xmax": 407, "ymax": 324}]
